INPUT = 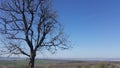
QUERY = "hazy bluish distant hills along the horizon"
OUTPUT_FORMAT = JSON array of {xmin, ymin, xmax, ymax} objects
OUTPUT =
[{"xmin": 0, "ymin": 57, "xmax": 120, "ymax": 61}]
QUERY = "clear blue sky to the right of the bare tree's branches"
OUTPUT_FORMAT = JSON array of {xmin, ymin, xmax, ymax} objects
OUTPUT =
[{"xmin": 41, "ymin": 0, "xmax": 120, "ymax": 58}]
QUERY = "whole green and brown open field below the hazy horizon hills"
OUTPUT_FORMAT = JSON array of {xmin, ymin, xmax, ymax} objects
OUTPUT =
[{"xmin": 0, "ymin": 60, "xmax": 120, "ymax": 68}]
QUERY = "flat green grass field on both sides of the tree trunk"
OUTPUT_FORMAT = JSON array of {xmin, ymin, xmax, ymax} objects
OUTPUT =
[{"xmin": 0, "ymin": 60, "xmax": 56, "ymax": 68}]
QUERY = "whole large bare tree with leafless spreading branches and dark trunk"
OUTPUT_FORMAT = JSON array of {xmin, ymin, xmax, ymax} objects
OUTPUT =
[{"xmin": 0, "ymin": 0, "xmax": 68, "ymax": 68}]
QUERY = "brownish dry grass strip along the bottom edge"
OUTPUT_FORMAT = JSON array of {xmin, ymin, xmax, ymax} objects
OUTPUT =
[{"xmin": 0, "ymin": 62, "xmax": 120, "ymax": 68}]
